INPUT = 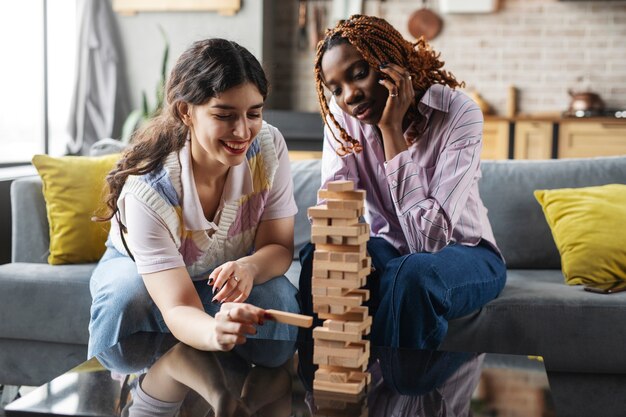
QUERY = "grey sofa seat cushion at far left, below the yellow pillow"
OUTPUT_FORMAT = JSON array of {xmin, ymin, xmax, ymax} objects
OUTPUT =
[{"xmin": 0, "ymin": 262, "xmax": 96, "ymax": 344}]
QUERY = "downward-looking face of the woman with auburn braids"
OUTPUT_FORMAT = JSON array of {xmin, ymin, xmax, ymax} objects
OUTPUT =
[{"xmin": 321, "ymin": 43, "xmax": 389, "ymax": 124}]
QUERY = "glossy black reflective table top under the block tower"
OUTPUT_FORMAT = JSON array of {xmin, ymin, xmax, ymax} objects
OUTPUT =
[{"xmin": 5, "ymin": 333, "xmax": 556, "ymax": 417}]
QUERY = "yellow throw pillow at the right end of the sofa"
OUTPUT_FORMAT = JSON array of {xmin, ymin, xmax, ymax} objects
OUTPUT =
[{"xmin": 535, "ymin": 184, "xmax": 626, "ymax": 285}]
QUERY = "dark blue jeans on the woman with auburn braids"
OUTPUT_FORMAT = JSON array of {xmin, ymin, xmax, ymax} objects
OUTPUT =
[{"xmin": 300, "ymin": 237, "xmax": 506, "ymax": 350}]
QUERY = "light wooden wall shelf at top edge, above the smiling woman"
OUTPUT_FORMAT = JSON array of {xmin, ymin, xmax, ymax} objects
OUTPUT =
[{"xmin": 113, "ymin": 0, "xmax": 241, "ymax": 16}]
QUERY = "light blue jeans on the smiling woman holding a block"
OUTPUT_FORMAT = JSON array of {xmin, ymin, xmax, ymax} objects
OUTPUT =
[{"xmin": 88, "ymin": 242, "xmax": 300, "ymax": 358}]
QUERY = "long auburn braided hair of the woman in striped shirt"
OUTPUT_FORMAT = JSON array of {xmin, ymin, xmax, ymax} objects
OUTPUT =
[{"xmin": 314, "ymin": 14, "xmax": 465, "ymax": 156}]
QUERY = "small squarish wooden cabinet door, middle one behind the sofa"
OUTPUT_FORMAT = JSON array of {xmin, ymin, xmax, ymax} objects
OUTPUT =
[{"xmin": 513, "ymin": 120, "xmax": 554, "ymax": 159}]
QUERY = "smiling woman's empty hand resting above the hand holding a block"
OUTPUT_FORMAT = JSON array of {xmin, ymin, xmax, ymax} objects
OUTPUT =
[{"xmin": 209, "ymin": 261, "xmax": 254, "ymax": 303}]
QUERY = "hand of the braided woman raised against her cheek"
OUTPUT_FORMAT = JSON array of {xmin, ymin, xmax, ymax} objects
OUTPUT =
[{"xmin": 378, "ymin": 64, "xmax": 415, "ymax": 133}]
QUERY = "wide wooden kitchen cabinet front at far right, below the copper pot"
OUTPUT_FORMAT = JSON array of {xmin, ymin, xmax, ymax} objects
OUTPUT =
[{"xmin": 557, "ymin": 120, "xmax": 626, "ymax": 158}]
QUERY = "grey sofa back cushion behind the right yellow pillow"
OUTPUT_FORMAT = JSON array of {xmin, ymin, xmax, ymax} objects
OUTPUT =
[{"xmin": 479, "ymin": 156, "xmax": 626, "ymax": 269}]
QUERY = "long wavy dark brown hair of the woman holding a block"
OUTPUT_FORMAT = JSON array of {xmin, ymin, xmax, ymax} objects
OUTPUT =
[{"xmin": 95, "ymin": 38, "xmax": 269, "ymax": 221}]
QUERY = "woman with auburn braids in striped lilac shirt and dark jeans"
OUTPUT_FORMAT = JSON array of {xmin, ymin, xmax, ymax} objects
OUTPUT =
[{"xmin": 300, "ymin": 15, "xmax": 506, "ymax": 349}]
